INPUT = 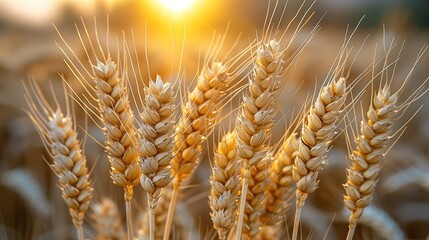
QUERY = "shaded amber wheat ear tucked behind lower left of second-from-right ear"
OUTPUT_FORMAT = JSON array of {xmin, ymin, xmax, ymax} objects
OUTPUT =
[{"xmin": 263, "ymin": 133, "xmax": 298, "ymax": 225}]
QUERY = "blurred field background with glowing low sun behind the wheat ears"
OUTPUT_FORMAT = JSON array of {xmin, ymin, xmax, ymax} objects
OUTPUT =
[{"xmin": 0, "ymin": 0, "xmax": 429, "ymax": 239}]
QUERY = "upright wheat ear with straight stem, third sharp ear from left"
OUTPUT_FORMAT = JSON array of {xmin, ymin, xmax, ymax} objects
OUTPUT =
[{"xmin": 138, "ymin": 76, "xmax": 174, "ymax": 240}]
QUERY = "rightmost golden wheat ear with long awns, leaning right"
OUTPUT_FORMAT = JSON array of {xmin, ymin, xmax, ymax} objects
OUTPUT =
[{"xmin": 344, "ymin": 42, "xmax": 428, "ymax": 240}]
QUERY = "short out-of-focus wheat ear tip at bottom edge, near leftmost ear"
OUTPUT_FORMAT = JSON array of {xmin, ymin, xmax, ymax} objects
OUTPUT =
[{"xmin": 92, "ymin": 198, "xmax": 125, "ymax": 240}]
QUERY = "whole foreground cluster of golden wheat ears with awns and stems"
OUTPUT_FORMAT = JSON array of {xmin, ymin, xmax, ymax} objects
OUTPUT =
[{"xmin": 24, "ymin": 0, "xmax": 427, "ymax": 240}]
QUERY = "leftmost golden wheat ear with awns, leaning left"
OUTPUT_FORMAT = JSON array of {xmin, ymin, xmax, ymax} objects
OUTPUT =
[{"xmin": 24, "ymin": 81, "xmax": 93, "ymax": 240}]
